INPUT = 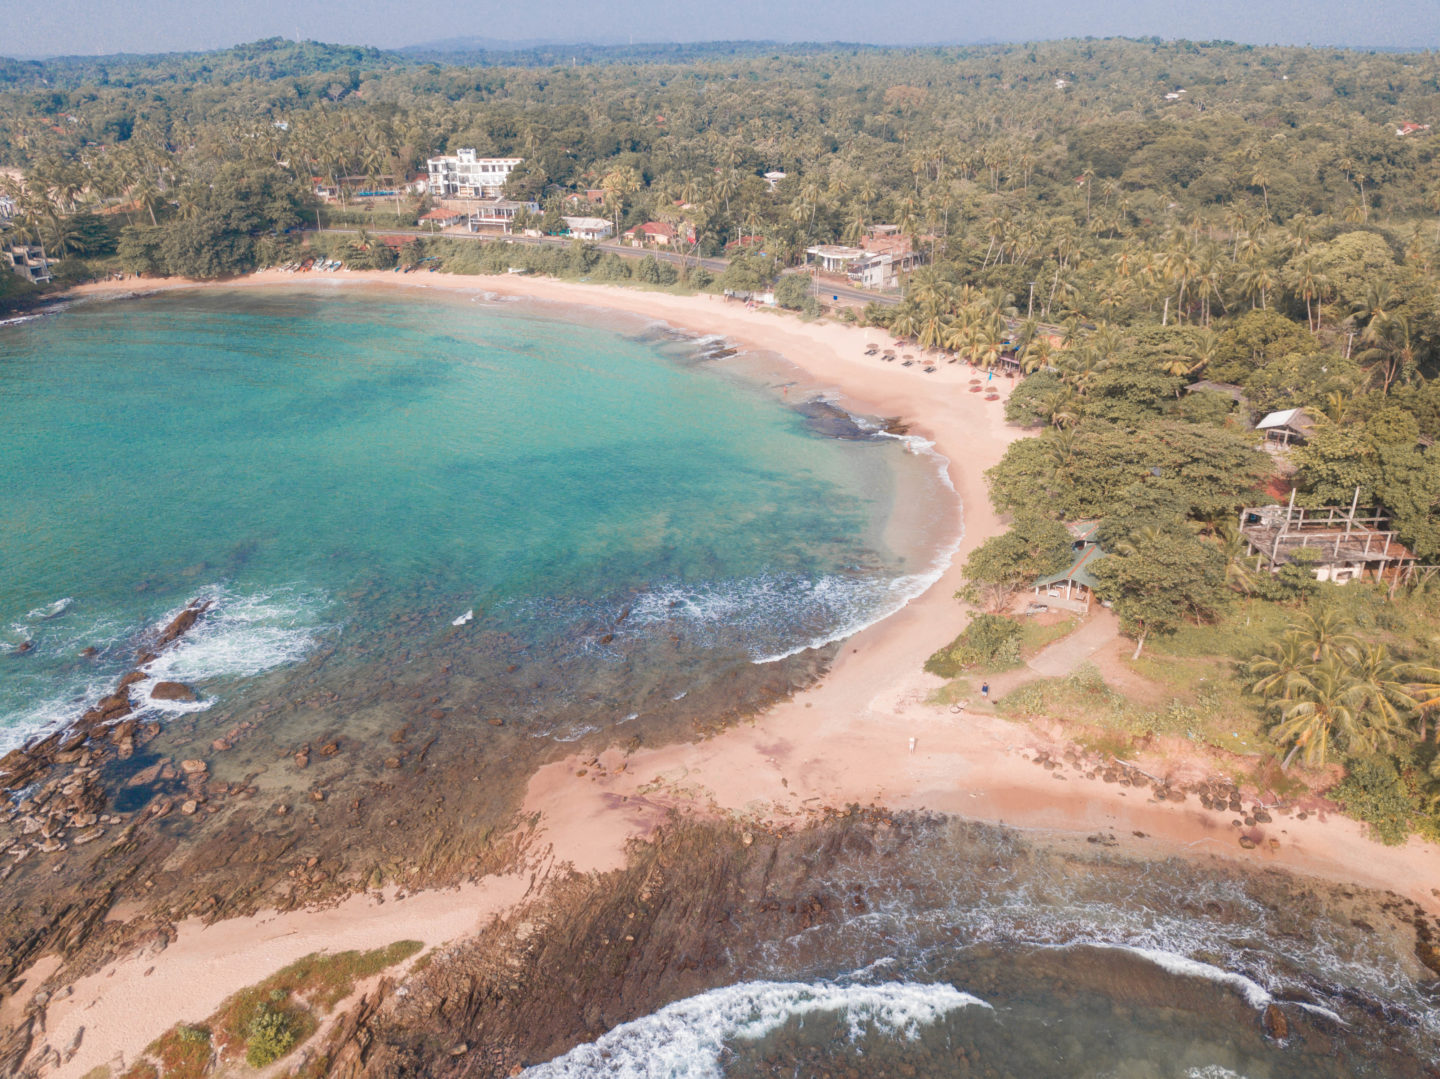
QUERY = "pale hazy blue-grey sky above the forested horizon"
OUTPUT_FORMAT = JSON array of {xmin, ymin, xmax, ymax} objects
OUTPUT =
[{"xmin": 8, "ymin": 0, "xmax": 1440, "ymax": 56}]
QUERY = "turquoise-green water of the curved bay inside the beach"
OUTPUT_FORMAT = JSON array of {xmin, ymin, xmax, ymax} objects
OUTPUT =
[{"xmin": 0, "ymin": 288, "xmax": 945, "ymax": 745}]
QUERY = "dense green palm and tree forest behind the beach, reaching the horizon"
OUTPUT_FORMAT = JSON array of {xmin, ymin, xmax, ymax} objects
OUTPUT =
[{"xmin": 0, "ymin": 33, "xmax": 1440, "ymax": 837}]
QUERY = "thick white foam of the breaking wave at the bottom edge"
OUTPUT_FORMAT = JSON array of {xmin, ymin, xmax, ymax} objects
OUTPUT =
[{"xmin": 524, "ymin": 981, "xmax": 989, "ymax": 1079}]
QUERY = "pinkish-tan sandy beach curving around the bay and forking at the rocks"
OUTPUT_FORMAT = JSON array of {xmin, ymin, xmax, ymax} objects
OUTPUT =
[{"xmin": 22, "ymin": 271, "xmax": 1440, "ymax": 1076}]
